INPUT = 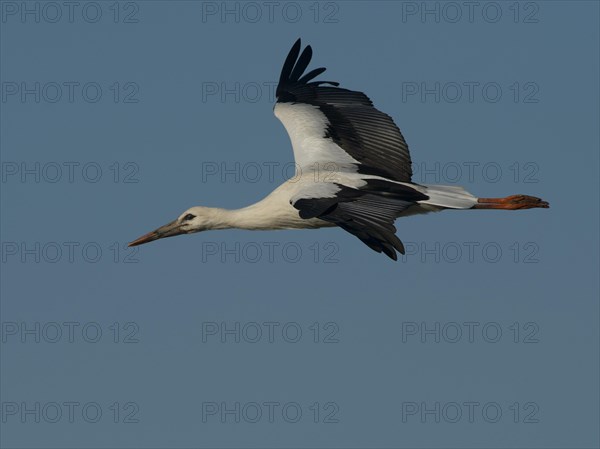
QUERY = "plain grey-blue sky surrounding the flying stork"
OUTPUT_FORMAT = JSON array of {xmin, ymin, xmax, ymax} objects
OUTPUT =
[{"xmin": 0, "ymin": 0, "xmax": 600, "ymax": 449}]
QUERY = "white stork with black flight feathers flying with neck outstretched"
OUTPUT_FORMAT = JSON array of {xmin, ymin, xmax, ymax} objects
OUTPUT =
[{"xmin": 129, "ymin": 39, "xmax": 549, "ymax": 260}]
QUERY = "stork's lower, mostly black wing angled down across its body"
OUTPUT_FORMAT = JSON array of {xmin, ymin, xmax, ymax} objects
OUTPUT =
[{"xmin": 292, "ymin": 179, "xmax": 428, "ymax": 260}]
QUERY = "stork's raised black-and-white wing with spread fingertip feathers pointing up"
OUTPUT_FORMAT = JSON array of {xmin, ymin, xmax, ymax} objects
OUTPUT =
[{"xmin": 274, "ymin": 39, "xmax": 412, "ymax": 182}]
